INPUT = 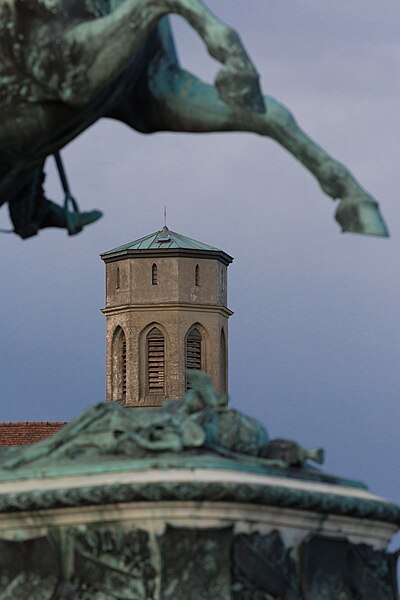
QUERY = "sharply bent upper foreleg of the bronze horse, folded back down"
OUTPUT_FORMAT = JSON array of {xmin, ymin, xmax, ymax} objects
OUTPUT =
[{"xmin": 57, "ymin": 0, "xmax": 265, "ymax": 113}]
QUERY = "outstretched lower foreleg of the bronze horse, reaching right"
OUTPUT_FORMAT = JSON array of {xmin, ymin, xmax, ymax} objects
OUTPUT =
[{"xmin": 143, "ymin": 64, "xmax": 388, "ymax": 237}]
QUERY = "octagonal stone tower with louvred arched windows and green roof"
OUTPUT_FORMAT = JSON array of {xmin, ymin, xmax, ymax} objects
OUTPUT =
[{"xmin": 101, "ymin": 226, "xmax": 233, "ymax": 406}]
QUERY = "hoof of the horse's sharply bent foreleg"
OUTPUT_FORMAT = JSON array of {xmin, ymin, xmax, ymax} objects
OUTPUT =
[{"xmin": 215, "ymin": 67, "xmax": 266, "ymax": 113}]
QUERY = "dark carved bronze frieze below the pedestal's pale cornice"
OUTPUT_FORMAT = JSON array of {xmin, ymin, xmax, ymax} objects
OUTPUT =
[{"xmin": 0, "ymin": 524, "xmax": 398, "ymax": 600}]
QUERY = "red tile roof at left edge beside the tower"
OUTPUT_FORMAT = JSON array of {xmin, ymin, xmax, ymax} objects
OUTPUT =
[{"xmin": 0, "ymin": 421, "xmax": 66, "ymax": 446}]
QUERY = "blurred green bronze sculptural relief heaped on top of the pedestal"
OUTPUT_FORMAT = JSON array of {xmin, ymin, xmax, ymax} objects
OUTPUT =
[{"xmin": 0, "ymin": 370, "xmax": 322, "ymax": 481}]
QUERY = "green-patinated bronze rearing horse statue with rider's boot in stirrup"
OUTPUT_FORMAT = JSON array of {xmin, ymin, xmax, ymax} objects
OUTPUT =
[{"xmin": 0, "ymin": 0, "xmax": 388, "ymax": 238}]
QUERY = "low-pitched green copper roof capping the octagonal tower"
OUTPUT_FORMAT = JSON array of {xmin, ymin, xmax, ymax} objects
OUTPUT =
[{"xmin": 101, "ymin": 225, "xmax": 221, "ymax": 256}]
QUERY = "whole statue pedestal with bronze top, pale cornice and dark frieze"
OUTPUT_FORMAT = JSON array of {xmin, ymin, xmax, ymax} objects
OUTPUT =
[{"xmin": 0, "ymin": 378, "xmax": 400, "ymax": 600}]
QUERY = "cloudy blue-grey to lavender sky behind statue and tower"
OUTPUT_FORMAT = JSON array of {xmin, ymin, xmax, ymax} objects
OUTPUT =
[{"xmin": 0, "ymin": 0, "xmax": 400, "ymax": 516}]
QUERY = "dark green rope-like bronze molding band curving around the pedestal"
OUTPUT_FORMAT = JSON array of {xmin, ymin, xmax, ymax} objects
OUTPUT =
[{"xmin": 0, "ymin": 481, "xmax": 400, "ymax": 526}]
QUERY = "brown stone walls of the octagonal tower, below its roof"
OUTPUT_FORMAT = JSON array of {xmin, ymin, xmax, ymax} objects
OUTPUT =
[{"xmin": 103, "ymin": 251, "xmax": 231, "ymax": 406}]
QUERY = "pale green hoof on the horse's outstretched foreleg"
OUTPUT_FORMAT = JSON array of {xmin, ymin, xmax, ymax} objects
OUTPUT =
[{"xmin": 335, "ymin": 199, "xmax": 389, "ymax": 237}]
